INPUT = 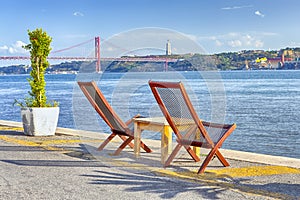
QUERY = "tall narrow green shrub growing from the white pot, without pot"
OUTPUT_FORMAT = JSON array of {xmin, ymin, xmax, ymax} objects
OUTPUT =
[{"xmin": 14, "ymin": 28, "xmax": 58, "ymax": 107}]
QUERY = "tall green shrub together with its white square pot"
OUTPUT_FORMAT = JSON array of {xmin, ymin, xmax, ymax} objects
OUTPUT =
[{"xmin": 15, "ymin": 29, "xmax": 59, "ymax": 136}]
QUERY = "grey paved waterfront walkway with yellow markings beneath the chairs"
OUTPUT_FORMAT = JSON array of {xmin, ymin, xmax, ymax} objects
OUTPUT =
[{"xmin": 0, "ymin": 121, "xmax": 300, "ymax": 199}]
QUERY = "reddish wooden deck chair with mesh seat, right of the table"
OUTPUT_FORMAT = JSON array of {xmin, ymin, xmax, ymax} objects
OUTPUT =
[{"xmin": 149, "ymin": 80, "xmax": 236, "ymax": 174}]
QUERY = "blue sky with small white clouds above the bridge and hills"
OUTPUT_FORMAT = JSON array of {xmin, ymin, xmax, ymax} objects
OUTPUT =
[{"xmin": 0, "ymin": 0, "xmax": 300, "ymax": 66}]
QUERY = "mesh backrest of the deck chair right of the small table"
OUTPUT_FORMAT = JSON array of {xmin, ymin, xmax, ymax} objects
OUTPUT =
[{"xmin": 149, "ymin": 81, "xmax": 213, "ymax": 145}]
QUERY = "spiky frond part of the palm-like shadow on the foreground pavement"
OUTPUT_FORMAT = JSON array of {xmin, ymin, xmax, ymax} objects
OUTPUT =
[{"xmin": 82, "ymin": 170, "xmax": 226, "ymax": 199}]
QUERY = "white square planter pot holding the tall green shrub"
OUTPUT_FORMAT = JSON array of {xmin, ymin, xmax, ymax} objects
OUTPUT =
[{"xmin": 21, "ymin": 107, "xmax": 59, "ymax": 136}]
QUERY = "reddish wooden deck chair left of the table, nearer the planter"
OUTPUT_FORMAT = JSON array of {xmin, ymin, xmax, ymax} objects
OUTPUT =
[{"xmin": 78, "ymin": 81, "xmax": 152, "ymax": 155}]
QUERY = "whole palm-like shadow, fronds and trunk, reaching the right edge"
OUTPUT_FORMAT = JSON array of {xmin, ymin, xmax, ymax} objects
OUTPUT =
[{"xmin": 82, "ymin": 169, "xmax": 300, "ymax": 199}]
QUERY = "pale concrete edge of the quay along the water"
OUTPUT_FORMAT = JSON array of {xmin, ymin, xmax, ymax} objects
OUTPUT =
[{"xmin": 0, "ymin": 120, "xmax": 300, "ymax": 169}]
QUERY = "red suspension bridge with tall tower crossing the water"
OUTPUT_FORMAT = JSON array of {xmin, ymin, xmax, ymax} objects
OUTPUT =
[{"xmin": 0, "ymin": 37, "xmax": 178, "ymax": 72}]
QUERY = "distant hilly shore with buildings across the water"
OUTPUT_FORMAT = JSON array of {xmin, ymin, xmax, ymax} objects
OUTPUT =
[{"xmin": 0, "ymin": 48, "xmax": 300, "ymax": 74}]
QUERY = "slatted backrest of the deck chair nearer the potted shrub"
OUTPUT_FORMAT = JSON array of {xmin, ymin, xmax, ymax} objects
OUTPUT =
[{"xmin": 78, "ymin": 81, "xmax": 128, "ymax": 134}]
